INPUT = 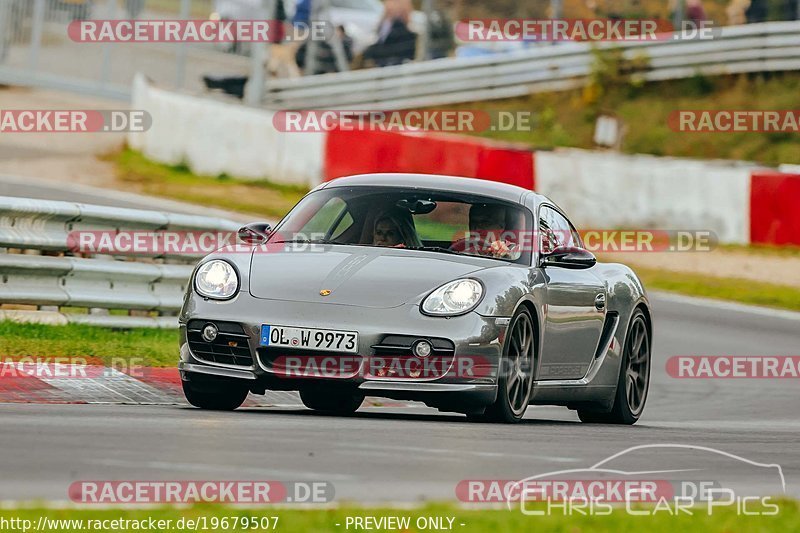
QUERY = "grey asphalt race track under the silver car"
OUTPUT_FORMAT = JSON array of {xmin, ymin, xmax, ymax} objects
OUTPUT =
[{"xmin": 0, "ymin": 295, "xmax": 800, "ymax": 502}]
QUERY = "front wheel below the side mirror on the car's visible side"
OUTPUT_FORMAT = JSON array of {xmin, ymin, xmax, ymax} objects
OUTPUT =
[{"xmin": 476, "ymin": 307, "xmax": 536, "ymax": 424}]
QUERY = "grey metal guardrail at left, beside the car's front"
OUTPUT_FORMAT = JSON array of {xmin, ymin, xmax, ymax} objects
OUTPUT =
[{"xmin": 0, "ymin": 197, "xmax": 240, "ymax": 327}]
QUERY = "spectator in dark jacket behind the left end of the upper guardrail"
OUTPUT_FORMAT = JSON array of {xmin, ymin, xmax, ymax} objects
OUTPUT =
[{"xmin": 364, "ymin": 0, "xmax": 417, "ymax": 67}]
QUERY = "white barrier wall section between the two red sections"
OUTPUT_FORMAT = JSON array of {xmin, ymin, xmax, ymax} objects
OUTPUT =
[{"xmin": 535, "ymin": 149, "xmax": 753, "ymax": 244}]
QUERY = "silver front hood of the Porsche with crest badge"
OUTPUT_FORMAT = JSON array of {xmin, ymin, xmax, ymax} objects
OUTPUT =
[{"xmin": 250, "ymin": 246, "xmax": 497, "ymax": 309}]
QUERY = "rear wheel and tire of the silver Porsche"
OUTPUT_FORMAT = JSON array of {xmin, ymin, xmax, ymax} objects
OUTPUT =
[{"xmin": 578, "ymin": 308, "xmax": 651, "ymax": 425}]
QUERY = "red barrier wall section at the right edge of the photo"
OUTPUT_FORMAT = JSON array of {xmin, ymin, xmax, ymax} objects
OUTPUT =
[{"xmin": 750, "ymin": 171, "xmax": 800, "ymax": 245}]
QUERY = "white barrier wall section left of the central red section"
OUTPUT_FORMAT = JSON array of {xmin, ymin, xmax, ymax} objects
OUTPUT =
[{"xmin": 128, "ymin": 76, "xmax": 325, "ymax": 187}]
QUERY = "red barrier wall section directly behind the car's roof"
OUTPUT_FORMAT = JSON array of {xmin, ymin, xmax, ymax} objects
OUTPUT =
[{"xmin": 324, "ymin": 130, "xmax": 535, "ymax": 190}]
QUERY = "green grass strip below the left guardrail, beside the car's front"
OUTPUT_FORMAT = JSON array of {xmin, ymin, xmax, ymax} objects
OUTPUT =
[{"xmin": 0, "ymin": 321, "xmax": 178, "ymax": 366}]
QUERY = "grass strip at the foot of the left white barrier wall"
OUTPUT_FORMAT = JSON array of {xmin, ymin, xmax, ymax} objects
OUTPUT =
[{"xmin": 102, "ymin": 148, "xmax": 308, "ymax": 220}]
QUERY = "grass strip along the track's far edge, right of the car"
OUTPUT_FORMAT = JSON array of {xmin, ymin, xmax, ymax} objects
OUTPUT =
[{"xmin": 634, "ymin": 267, "xmax": 800, "ymax": 311}]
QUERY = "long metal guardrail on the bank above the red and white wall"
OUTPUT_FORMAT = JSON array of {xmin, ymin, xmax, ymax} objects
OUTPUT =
[{"xmin": 264, "ymin": 21, "xmax": 800, "ymax": 110}]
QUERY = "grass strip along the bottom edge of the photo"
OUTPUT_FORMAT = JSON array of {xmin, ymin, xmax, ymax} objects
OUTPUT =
[{"xmin": 0, "ymin": 500, "xmax": 800, "ymax": 533}]
